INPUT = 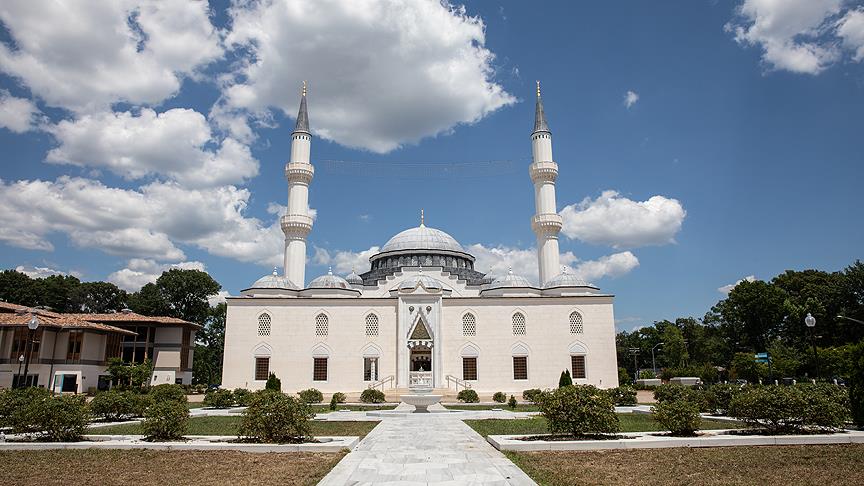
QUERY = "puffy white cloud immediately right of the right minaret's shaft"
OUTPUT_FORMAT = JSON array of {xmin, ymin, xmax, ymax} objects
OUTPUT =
[{"xmin": 560, "ymin": 190, "xmax": 687, "ymax": 248}]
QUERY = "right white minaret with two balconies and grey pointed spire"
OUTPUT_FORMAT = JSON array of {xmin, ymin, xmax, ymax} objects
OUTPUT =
[{"xmin": 530, "ymin": 81, "xmax": 562, "ymax": 286}]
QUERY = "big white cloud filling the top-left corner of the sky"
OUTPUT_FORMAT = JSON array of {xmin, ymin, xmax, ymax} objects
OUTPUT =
[{"xmin": 0, "ymin": 0, "xmax": 223, "ymax": 111}]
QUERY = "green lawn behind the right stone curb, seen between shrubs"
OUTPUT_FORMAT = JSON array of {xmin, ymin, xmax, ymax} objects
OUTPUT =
[{"xmin": 465, "ymin": 413, "xmax": 740, "ymax": 437}]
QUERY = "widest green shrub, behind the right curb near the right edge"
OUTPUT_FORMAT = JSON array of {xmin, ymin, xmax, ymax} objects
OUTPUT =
[{"xmin": 728, "ymin": 383, "xmax": 849, "ymax": 434}]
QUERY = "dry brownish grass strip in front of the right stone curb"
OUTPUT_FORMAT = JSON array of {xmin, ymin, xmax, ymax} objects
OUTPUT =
[{"xmin": 505, "ymin": 444, "xmax": 864, "ymax": 486}]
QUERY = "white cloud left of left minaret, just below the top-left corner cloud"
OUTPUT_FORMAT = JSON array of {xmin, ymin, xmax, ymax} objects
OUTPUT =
[{"xmin": 46, "ymin": 108, "xmax": 258, "ymax": 187}]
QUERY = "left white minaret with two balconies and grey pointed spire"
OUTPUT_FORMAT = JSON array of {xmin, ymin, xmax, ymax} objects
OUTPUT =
[{"xmin": 280, "ymin": 81, "xmax": 315, "ymax": 288}]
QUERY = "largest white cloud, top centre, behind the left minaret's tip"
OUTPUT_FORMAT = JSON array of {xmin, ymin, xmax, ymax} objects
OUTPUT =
[{"xmin": 221, "ymin": 0, "xmax": 516, "ymax": 152}]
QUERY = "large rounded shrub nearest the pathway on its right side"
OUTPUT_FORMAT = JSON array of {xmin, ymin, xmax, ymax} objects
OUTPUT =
[{"xmin": 537, "ymin": 385, "xmax": 619, "ymax": 436}]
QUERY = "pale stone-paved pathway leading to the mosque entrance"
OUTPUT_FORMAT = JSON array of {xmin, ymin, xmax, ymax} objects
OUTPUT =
[{"xmin": 318, "ymin": 406, "xmax": 536, "ymax": 486}]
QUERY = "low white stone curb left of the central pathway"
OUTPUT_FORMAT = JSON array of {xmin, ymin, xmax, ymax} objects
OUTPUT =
[{"xmin": 0, "ymin": 435, "xmax": 360, "ymax": 453}]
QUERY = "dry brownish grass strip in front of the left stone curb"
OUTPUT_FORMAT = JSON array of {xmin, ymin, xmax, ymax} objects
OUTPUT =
[{"xmin": 0, "ymin": 450, "xmax": 345, "ymax": 485}]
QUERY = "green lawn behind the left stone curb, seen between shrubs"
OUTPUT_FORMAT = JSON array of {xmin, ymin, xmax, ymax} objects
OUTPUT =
[{"xmin": 89, "ymin": 417, "xmax": 378, "ymax": 437}]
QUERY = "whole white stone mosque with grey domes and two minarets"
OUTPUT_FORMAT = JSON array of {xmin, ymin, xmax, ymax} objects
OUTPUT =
[{"xmin": 222, "ymin": 83, "xmax": 618, "ymax": 397}]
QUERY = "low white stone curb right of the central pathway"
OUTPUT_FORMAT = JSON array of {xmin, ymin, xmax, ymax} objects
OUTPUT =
[{"xmin": 486, "ymin": 430, "xmax": 864, "ymax": 452}]
